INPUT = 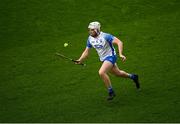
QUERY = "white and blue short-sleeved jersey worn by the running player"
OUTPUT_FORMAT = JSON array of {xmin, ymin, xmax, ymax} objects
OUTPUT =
[{"xmin": 87, "ymin": 32, "xmax": 116, "ymax": 64}]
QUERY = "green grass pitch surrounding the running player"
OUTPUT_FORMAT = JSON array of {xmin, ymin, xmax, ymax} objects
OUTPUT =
[{"xmin": 0, "ymin": 0, "xmax": 180, "ymax": 122}]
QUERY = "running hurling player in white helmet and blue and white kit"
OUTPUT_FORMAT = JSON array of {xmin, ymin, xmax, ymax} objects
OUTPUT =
[{"xmin": 76, "ymin": 22, "xmax": 140, "ymax": 100}]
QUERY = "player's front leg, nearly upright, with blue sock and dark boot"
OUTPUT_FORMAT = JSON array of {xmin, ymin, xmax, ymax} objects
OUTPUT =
[{"xmin": 99, "ymin": 61, "xmax": 115, "ymax": 100}]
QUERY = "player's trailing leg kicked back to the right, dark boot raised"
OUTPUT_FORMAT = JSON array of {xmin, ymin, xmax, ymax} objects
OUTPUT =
[{"xmin": 110, "ymin": 63, "xmax": 140, "ymax": 89}]
